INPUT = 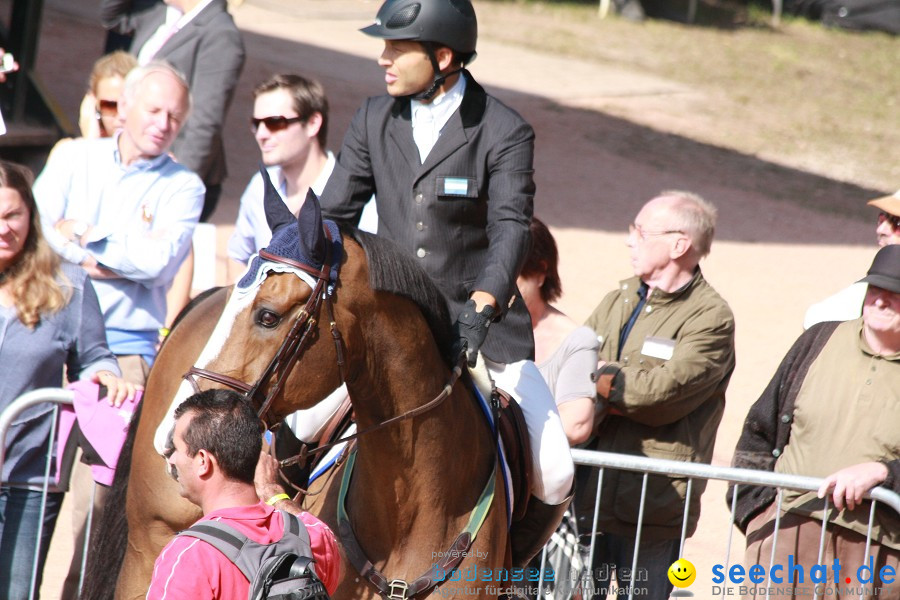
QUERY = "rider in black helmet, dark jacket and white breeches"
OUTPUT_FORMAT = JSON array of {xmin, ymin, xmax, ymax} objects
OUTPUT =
[{"xmin": 322, "ymin": 0, "xmax": 573, "ymax": 554}]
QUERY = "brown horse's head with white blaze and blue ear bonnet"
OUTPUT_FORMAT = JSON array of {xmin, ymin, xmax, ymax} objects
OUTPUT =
[{"xmin": 154, "ymin": 169, "xmax": 343, "ymax": 454}]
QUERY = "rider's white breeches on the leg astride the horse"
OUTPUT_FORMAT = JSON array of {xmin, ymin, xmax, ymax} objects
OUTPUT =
[{"xmin": 484, "ymin": 360, "xmax": 575, "ymax": 504}]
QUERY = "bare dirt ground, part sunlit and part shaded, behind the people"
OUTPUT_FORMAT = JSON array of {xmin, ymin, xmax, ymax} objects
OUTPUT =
[{"xmin": 8, "ymin": 0, "xmax": 877, "ymax": 598}]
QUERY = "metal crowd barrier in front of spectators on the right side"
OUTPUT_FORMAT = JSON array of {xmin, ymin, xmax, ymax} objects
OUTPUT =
[{"xmin": 537, "ymin": 448, "xmax": 900, "ymax": 600}]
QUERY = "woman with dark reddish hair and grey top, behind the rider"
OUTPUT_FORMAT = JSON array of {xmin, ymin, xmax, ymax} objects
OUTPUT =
[{"xmin": 516, "ymin": 217, "xmax": 599, "ymax": 445}]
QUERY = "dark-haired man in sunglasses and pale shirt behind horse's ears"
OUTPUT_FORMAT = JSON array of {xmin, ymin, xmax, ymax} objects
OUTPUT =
[{"xmin": 228, "ymin": 74, "xmax": 377, "ymax": 281}]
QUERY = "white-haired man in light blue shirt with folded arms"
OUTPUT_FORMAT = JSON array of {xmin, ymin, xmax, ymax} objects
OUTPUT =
[{"xmin": 34, "ymin": 63, "xmax": 204, "ymax": 598}]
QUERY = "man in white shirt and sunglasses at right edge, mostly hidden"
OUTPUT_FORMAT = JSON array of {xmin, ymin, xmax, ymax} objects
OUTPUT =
[{"xmin": 803, "ymin": 190, "xmax": 900, "ymax": 329}]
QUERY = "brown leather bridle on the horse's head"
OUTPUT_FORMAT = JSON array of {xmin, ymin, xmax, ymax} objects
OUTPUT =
[{"xmin": 183, "ymin": 244, "xmax": 344, "ymax": 429}]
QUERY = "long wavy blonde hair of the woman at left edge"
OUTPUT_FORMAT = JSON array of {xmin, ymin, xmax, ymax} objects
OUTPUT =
[{"xmin": 0, "ymin": 160, "xmax": 71, "ymax": 329}]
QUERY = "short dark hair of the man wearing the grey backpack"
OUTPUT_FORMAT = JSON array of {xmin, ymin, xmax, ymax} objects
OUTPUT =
[{"xmin": 175, "ymin": 389, "xmax": 262, "ymax": 484}]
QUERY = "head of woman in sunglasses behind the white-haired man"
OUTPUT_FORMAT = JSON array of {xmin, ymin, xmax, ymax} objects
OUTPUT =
[{"xmin": 78, "ymin": 50, "xmax": 137, "ymax": 138}]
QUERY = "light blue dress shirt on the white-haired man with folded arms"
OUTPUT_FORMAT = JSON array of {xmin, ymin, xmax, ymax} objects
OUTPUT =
[{"xmin": 34, "ymin": 136, "xmax": 205, "ymax": 356}]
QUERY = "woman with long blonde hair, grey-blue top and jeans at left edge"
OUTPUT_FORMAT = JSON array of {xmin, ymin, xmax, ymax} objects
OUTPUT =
[{"xmin": 0, "ymin": 161, "xmax": 135, "ymax": 600}]
